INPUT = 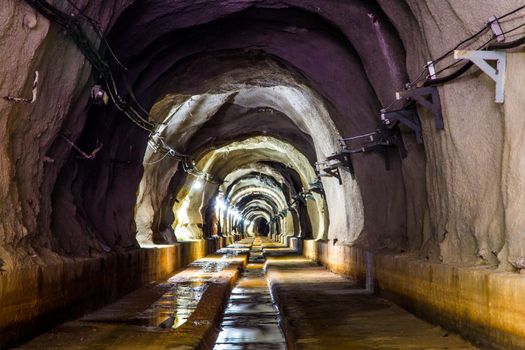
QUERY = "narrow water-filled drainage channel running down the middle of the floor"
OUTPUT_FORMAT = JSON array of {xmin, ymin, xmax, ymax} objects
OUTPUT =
[{"xmin": 214, "ymin": 237, "xmax": 286, "ymax": 350}]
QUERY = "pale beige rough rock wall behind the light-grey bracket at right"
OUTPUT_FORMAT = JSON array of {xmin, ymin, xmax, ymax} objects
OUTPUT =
[{"xmin": 379, "ymin": 1, "xmax": 525, "ymax": 268}]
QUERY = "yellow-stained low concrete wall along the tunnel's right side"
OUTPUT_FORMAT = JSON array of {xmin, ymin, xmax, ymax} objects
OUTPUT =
[{"xmin": 304, "ymin": 241, "xmax": 525, "ymax": 349}]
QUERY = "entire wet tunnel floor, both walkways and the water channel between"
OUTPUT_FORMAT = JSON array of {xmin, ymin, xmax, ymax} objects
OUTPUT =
[{"xmin": 16, "ymin": 237, "xmax": 475, "ymax": 350}]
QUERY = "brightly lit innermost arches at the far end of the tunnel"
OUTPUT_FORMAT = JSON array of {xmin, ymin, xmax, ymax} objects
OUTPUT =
[{"xmin": 164, "ymin": 136, "xmax": 329, "ymax": 243}]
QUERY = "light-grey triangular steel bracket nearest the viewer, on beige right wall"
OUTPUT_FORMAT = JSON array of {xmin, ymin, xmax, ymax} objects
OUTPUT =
[{"xmin": 454, "ymin": 50, "xmax": 507, "ymax": 103}]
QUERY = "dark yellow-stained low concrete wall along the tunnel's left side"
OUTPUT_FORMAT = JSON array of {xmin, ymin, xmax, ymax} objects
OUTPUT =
[{"xmin": 0, "ymin": 239, "xmax": 228, "ymax": 348}]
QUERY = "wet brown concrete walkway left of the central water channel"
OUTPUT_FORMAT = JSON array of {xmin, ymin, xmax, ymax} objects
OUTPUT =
[{"xmin": 20, "ymin": 244, "xmax": 249, "ymax": 350}]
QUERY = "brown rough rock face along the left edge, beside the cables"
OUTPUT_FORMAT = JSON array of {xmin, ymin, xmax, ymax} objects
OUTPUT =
[{"xmin": 0, "ymin": 0, "xmax": 129, "ymax": 268}]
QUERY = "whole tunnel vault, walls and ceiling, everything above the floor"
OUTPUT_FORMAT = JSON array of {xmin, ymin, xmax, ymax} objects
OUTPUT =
[{"xmin": 5, "ymin": 0, "xmax": 525, "ymax": 347}]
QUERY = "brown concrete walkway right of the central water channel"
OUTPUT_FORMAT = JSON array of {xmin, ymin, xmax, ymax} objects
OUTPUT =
[{"xmin": 266, "ymin": 256, "xmax": 475, "ymax": 350}]
